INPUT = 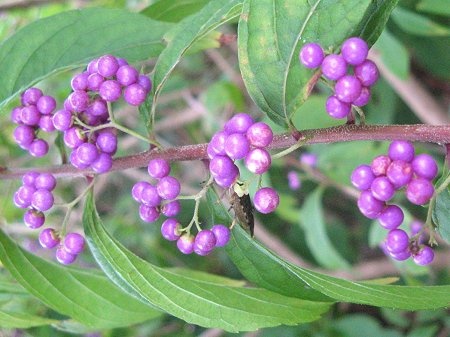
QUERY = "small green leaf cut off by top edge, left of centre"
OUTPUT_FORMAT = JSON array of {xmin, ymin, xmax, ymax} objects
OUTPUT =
[{"xmin": 141, "ymin": 0, "xmax": 209, "ymax": 22}]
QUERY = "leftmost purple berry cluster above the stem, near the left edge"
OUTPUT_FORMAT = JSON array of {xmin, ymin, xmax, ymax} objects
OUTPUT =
[{"xmin": 11, "ymin": 88, "xmax": 56, "ymax": 157}]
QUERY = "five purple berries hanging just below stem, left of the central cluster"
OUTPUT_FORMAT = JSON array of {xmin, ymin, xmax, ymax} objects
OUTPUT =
[{"xmin": 131, "ymin": 159, "xmax": 181, "ymax": 222}]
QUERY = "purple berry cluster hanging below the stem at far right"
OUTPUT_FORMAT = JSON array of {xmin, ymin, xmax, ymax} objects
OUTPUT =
[{"xmin": 351, "ymin": 141, "xmax": 438, "ymax": 265}]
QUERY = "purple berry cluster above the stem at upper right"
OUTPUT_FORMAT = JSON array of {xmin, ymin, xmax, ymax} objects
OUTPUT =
[{"xmin": 299, "ymin": 37, "xmax": 379, "ymax": 119}]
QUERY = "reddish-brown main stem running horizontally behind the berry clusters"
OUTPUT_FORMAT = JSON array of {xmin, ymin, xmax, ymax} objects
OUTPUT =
[{"xmin": 0, "ymin": 124, "xmax": 450, "ymax": 179}]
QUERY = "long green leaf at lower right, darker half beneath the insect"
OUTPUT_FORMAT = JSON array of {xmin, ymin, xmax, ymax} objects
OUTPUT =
[{"xmin": 227, "ymin": 227, "xmax": 450, "ymax": 310}]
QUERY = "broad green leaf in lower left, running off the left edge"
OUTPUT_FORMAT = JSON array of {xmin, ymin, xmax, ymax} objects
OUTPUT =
[{"xmin": 0, "ymin": 230, "xmax": 161, "ymax": 329}]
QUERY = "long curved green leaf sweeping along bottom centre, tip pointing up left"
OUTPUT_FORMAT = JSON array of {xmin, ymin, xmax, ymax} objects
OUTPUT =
[{"xmin": 83, "ymin": 190, "xmax": 329, "ymax": 332}]
